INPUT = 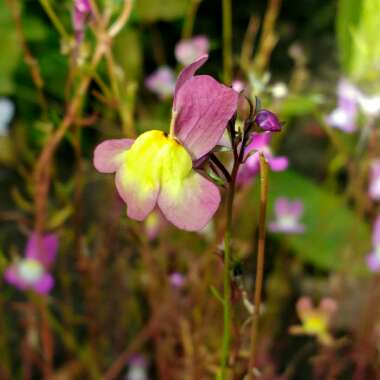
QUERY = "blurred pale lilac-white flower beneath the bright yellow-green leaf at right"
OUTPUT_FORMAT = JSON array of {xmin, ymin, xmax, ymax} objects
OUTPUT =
[{"xmin": 326, "ymin": 79, "xmax": 360, "ymax": 133}]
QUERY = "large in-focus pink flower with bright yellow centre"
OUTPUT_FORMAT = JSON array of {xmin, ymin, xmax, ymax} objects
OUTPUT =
[{"xmin": 94, "ymin": 55, "xmax": 239, "ymax": 231}]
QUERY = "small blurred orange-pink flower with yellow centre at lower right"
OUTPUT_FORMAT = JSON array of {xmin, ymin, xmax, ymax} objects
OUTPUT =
[{"xmin": 289, "ymin": 297, "xmax": 337, "ymax": 345}]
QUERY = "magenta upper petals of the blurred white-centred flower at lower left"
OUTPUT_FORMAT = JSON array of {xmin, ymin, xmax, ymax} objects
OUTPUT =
[{"xmin": 25, "ymin": 233, "xmax": 58, "ymax": 267}]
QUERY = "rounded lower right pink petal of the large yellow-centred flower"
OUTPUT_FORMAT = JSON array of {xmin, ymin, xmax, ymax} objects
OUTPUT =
[{"xmin": 158, "ymin": 172, "xmax": 220, "ymax": 231}]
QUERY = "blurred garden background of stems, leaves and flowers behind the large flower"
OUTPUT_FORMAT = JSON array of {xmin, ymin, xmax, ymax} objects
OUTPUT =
[{"xmin": 0, "ymin": 0, "xmax": 380, "ymax": 380}]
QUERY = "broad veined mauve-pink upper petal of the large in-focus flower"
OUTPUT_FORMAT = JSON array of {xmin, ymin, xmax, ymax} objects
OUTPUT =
[{"xmin": 174, "ymin": 75, "xmax": 239, "ymax": 159}]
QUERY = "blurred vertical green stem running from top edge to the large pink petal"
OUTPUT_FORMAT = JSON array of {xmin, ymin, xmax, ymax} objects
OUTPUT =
[{"xmin": 222, "ymin": 0, "xmax": 232, "ymax": 84}]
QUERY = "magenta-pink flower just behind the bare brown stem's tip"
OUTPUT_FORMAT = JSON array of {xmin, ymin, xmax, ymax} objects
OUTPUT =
[{"xmin": 237, "ymin": 132, "xmax": 288, "ymax": 185}]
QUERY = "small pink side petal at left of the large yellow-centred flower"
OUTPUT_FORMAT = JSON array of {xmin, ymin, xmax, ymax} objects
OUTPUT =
[{"xmin": 93, "ymin": 139, "xmax": 134, "ymax": 173}]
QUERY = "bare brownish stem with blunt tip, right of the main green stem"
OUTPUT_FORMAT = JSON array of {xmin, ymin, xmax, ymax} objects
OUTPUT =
[{"xmin": 248, "ymin": 152, "xmax": 268, "ymax": 379}]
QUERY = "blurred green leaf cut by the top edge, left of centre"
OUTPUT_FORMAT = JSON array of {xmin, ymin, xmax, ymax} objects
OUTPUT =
[{"xmin": 135, "ymin": 0, "xmax": 189, "ymax": 22}]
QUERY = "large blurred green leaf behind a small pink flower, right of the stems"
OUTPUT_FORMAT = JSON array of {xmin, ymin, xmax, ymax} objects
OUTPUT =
[{"xmin": 268, "ymin": 170, "xmax": 371, "ymax": 274}]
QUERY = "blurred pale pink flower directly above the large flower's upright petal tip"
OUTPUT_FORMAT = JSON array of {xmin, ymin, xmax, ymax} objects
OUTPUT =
[{"xmin": 175, "ymin": 36, "xmax": 210, "ymax": 65}]
